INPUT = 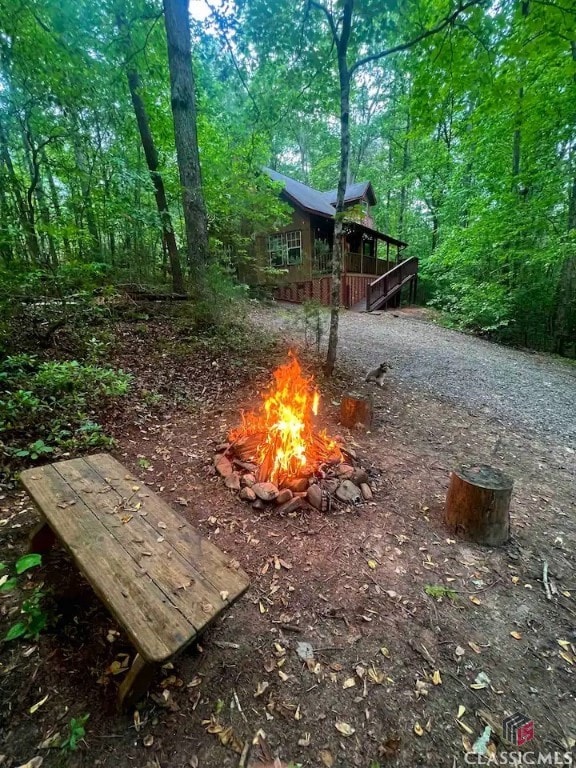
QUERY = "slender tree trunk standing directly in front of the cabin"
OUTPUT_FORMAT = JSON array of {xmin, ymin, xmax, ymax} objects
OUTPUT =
[{"xmin": 324, "ymin": 0, "xmax": 354, "ymax": 376}]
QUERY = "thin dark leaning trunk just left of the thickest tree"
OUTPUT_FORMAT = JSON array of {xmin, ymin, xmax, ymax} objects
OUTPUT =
[{"xmin": 127, "ymin": 69, "xmax": 185, "ymax": 293}]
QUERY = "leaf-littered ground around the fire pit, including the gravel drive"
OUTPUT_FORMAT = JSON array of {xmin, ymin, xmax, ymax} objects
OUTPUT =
[{"xmin": 0, "ymin": 308, "xmax": 576, "ymax": 768}]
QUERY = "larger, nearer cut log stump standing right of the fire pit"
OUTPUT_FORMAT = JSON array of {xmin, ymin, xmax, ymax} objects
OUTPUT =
[{"xmin": 444, "ymin": 464, "xmax": 514, "ymax": 547}]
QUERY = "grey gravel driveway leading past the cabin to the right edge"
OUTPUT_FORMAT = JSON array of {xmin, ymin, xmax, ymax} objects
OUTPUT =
[{"xmin": 262, "ymin": 304, "xmax": 576, "ymax": 446}]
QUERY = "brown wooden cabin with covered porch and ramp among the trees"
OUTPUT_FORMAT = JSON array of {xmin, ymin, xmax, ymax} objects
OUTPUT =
[{"xmin": 246, "ymin": 168, "xmax": 418, "ymax": 312}]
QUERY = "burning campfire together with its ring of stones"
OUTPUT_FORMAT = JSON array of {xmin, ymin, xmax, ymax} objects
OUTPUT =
[{"xmin": 214, "ymin": 355, "xmax": 372, "ymax": 512}]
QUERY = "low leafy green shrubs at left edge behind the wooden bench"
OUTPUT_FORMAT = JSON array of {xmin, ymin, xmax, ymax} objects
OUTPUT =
[{"xmin": 0, "ymin": 355, "xmax": 131, "ymax": 461}]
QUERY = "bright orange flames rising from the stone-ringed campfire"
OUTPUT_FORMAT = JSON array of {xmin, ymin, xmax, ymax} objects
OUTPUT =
[{"xmin": 229, "ymin": 357, "xmax": 342, "ymax": 485}]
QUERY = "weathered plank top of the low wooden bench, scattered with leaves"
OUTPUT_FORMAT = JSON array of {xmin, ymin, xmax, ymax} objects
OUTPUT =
[{"xmin": 21, "ymin": 454, "xmax": 249, "ymax": 662}]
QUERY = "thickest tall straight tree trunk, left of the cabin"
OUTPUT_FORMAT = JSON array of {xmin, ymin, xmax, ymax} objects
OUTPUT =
[{"xmin": 163, "ymin": 0, "xmax": 208, "ymax": 294}]
